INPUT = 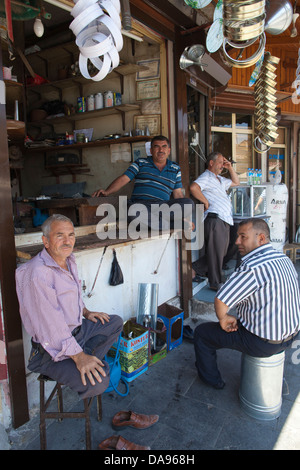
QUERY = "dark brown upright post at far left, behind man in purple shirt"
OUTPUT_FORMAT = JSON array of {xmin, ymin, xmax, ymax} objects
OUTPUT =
[{"xmin": 0, "ymin": 41, "xmax": 29, "ymax": 428}]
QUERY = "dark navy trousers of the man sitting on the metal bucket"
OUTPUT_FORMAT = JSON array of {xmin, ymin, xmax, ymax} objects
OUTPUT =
[{"xmin": 194, "ymin": 322, "xmax": 299, "ymax": 385}]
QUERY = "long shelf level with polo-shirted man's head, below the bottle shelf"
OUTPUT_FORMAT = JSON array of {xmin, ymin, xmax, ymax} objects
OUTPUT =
[{"xmin": 26, "ymin": 135, "xmax": 152, "ymax": 153}]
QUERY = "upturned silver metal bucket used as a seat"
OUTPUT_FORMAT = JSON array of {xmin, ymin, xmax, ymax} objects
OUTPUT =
[{"xmin": 239, "ymin": 351, "xmax": 285, "ymax": 421}]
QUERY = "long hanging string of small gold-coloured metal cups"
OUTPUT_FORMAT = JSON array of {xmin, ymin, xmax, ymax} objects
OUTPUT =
[{"xmin": 254, "ymin": 52, "xmax": 280, "ymax": 153}]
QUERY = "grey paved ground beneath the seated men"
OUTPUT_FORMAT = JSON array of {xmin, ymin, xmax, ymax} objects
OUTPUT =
[{"xmin": 8, "ymin": 262, "xmax": 300, "ymax": 451}]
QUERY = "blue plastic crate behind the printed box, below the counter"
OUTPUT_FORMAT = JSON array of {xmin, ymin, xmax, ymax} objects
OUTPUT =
[{"xmin": 157, "ymin": 303, "xmax": 184, "ymax": 351}]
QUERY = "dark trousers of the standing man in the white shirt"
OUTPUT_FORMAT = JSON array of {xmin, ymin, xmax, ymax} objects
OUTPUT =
[{"xmin": 192, "ymin": 215, "xmax": 230, "ymax": 288}]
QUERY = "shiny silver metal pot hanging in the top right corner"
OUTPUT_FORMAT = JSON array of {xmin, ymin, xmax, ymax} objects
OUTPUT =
[{"xmin": 265, "ymin": 0, "xmax": 293, "ymax": 35}]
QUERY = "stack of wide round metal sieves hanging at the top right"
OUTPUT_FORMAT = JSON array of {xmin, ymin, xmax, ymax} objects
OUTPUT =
[{"xmin": 223, "ymin": 0, "xmax": 266, "ymax": 68}]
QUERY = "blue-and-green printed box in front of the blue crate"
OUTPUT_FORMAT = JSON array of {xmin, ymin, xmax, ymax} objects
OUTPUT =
[{"xmin": 113, "ymin": 320, "xmax": 149, "ymax": 382}]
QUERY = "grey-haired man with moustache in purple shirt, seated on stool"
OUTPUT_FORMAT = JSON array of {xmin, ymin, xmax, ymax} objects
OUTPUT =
[{"xmin": 16, "ymin": 214, "xmax": 123, "ymax": 398}]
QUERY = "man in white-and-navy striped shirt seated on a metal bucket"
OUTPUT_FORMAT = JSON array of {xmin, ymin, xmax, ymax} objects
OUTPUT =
[{"xmin": 194, "ymin": 218, "xmax": 300, "ymax": 389}]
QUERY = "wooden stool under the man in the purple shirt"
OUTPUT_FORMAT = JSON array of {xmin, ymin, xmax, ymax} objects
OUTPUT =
[{"xmin": 38, "ymin": 375, "xmax": 102, "ymax": 450}]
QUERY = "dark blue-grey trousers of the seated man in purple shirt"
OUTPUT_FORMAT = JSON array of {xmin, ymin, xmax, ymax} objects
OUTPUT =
[{"xmin": 28, "ymin": 315, "xmax": 123, "ymax": 399}]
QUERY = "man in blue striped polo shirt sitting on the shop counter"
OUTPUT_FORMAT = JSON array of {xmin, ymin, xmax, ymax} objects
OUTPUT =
[{"xmin": 92, "ymin": 135, "xmax": 193, "ymax": 228}]
